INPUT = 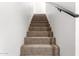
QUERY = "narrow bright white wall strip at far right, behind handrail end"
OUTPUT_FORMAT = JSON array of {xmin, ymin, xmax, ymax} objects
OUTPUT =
[{"xmin": 75, "ymin": 2, "xmax": 79, "ymax": 56}]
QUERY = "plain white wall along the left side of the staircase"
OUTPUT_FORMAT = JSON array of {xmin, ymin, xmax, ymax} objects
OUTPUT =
[{"xmin": 0, "ymin": 2, "xmax": 33, "ymax": 56}]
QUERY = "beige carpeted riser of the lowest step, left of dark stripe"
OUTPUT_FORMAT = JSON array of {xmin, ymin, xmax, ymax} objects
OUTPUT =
[{"xmin": 21, "ymin": 46, "xmax": 52, "ymax": 56}]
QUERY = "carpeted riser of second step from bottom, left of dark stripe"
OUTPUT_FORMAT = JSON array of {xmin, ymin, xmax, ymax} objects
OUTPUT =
[{"xmin": 24, "ymin": 37, "xmax": 51, "ymax": 44}]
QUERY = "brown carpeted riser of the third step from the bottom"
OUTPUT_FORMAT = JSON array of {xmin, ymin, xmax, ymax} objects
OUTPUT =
[{"xmin": 27, "ymin": 31, "xmax": 53, "ymax": 37}]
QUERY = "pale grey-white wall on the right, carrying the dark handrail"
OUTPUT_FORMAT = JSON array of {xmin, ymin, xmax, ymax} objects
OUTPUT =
[{"xmin": 46, "ymin": 2, "xmax": 75, "ymax": 56}]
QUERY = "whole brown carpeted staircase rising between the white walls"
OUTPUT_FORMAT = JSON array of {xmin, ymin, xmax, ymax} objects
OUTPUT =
[{"xmin": 20, "ymin": 14, "xmax": 60, "ymax": 56}]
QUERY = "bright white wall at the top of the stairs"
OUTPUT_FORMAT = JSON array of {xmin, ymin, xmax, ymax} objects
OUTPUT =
[{"xmin": 33, "ymin": 2, "xmax": 46, "ymax": 14}]
